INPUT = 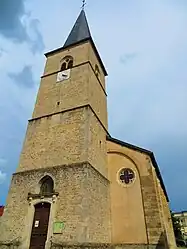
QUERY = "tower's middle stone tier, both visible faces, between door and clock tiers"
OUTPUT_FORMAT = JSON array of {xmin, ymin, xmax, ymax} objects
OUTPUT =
[{"xmin": 17, "ymin": 106, "xmax": 107, "ymax": 176}]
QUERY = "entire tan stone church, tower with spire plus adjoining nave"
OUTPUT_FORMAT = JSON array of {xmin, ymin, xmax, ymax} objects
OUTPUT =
[{"xmin": 0, "ymin": 9, "xmax": 176, "ymax": 249}]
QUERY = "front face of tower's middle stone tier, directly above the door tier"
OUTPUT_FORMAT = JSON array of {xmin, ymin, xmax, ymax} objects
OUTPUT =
[{"xmin": 17, "ymin": 108, "xmax": 88, "ymax": 172}]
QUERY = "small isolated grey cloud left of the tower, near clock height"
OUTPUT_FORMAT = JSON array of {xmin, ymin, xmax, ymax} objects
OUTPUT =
[{"xmin": 8, "ymin": 66, "xmax": 35, "ymax": 88}]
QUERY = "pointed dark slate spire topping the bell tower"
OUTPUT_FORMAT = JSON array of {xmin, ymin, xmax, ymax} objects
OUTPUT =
[{"xmin": 64, "ymin": 8, "xmax": 92, "ymax": 48}]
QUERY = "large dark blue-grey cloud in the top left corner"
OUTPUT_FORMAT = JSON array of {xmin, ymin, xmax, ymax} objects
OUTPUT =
[{"xmin": 0, "ymin": 0, "xmax": 45, "ymax": 55}]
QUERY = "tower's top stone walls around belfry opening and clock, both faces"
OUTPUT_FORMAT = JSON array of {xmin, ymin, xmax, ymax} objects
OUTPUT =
[{"xmin": 33, "ymin": 42, "xmax": 108, "ymax": 129}]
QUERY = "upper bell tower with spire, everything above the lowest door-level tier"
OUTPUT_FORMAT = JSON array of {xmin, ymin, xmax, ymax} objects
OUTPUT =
[{"xmin": 18, "ymin": 10, "xmax": 108, "ymax": 176}]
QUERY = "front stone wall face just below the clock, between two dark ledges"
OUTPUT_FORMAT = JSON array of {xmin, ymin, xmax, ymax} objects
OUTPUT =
[{"xmin": 33, "ymin": 61, "xmax": 90, "ymax": 118}]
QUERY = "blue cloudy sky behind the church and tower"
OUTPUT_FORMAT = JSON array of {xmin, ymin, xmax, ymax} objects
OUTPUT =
[{"xmin": 0, "ymin": 0, "xmax": 187, "ymax": 211}]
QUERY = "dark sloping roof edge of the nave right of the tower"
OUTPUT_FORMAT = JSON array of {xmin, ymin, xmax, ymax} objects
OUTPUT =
[{"xmin": 107, "ymin": 135, "xmax": 169, "ymax": 202}]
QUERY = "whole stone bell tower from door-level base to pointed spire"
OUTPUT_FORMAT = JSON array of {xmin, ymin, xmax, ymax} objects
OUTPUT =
[{"xmin": 0, "ymin": 10, "xmax": 110, "ymax": 249}]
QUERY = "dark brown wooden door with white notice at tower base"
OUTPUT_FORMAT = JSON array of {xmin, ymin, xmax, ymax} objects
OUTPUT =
[{"xmin": 30, "ymin": 202, "xmax": 51, "ymax": 249}]
